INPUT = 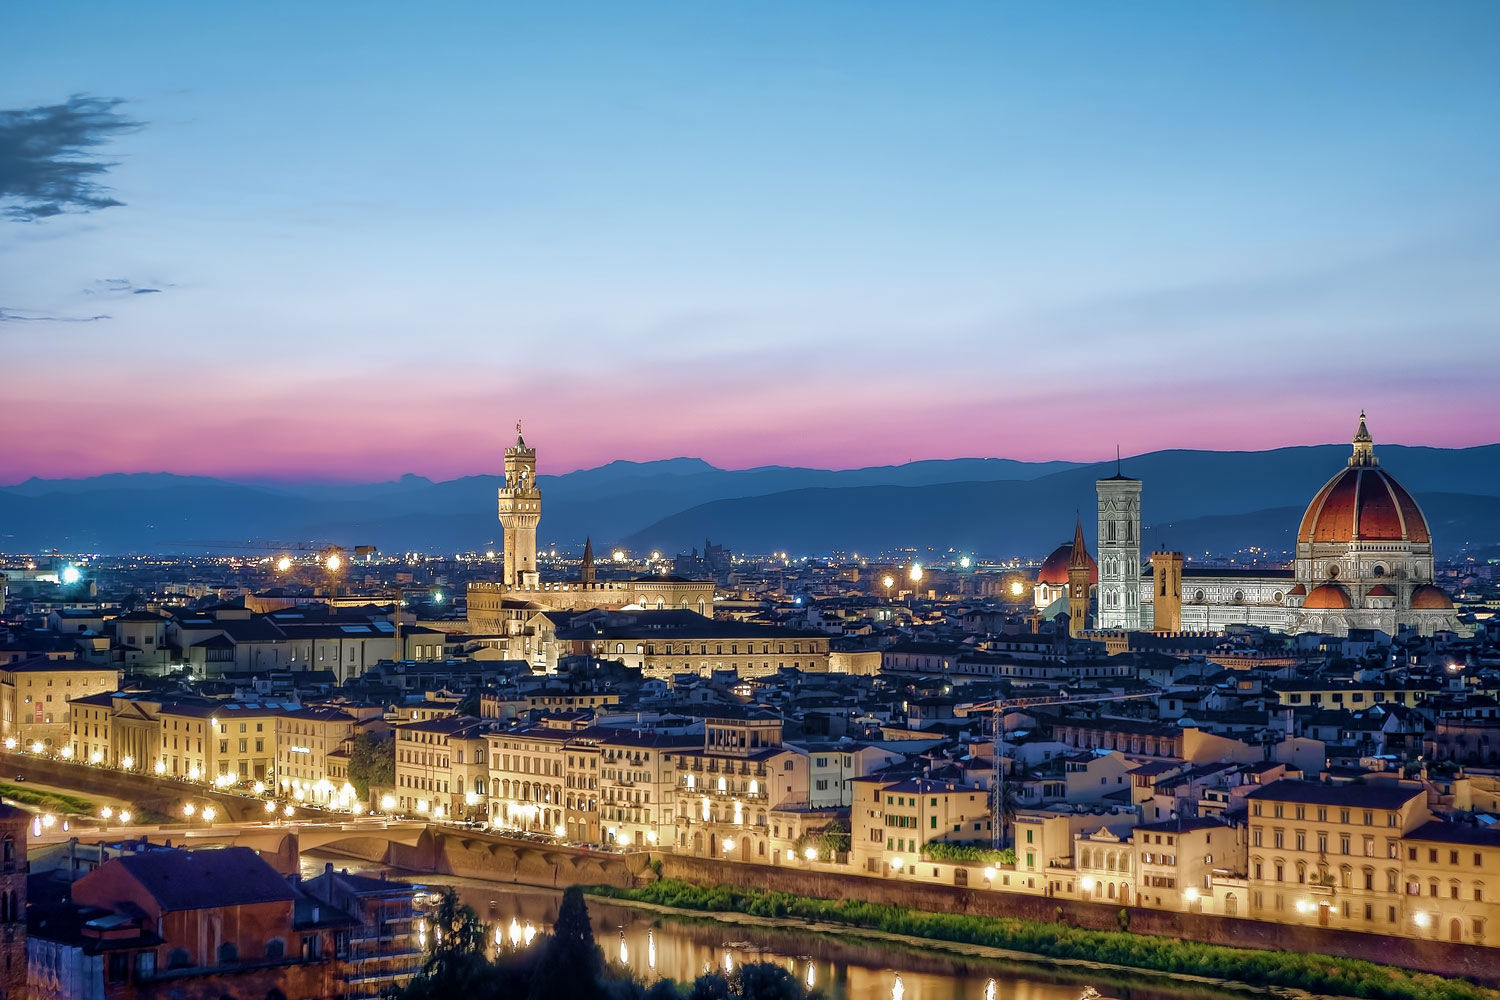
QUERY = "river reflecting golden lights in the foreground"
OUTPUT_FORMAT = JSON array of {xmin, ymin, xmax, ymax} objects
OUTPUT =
[{"xmin": 302, "ymin": 852, "xmax": 1244, "ymax": 1000}]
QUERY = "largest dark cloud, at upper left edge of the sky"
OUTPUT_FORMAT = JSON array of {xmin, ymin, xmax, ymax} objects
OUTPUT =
[{"xmin": 0, "ymin": 94, "xmax": 141, "ymax": 222}]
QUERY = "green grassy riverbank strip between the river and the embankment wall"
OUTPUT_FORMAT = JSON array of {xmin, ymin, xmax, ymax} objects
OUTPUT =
[{"xmin": 590, "ymin": 880, "xmax": 1500, "ymax": 1000}]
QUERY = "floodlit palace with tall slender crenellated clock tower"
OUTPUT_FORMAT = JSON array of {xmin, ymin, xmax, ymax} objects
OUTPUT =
[{"xmin": 468, "ymin": 424, "xmax": 714, "ymax": 634}]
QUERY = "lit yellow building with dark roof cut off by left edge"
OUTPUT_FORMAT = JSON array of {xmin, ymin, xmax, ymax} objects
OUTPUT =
[{"xmin": 0, "ymin": 657, "xmax": 120, "ymax": 754}]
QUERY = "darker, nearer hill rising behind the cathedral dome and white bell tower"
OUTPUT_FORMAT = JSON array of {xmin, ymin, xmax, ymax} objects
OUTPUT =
[{"xmin": 626, "ymin": 445, "xmax": 1500, "ymax": 556}]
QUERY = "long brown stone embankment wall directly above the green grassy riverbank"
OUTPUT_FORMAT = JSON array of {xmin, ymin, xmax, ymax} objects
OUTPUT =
[{"xmin": 660, "ymin": 855, "xmax": 1500, "ymax": 985}]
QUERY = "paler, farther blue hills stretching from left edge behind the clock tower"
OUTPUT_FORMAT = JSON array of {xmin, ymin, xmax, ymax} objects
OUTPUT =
[{"xmin": 0, "ymin": 459, "xmax": 1074, "ymax": 553}]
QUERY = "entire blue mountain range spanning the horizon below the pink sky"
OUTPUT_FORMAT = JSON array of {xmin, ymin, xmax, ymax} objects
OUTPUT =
[{"xmin": 0, "ymin": 445, "xmax": 1500, "ymax": 558}]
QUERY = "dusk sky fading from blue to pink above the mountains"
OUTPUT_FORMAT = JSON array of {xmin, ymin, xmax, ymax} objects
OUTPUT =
[{"xmin": 0, "ymin": 0, "xmax": 1500, "ymax": 483}]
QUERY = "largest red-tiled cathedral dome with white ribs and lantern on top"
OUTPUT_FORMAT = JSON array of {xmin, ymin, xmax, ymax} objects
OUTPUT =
[{"xmin": 1298, "ymin": 414, "xmax": 1433, "ymax": 544}]
